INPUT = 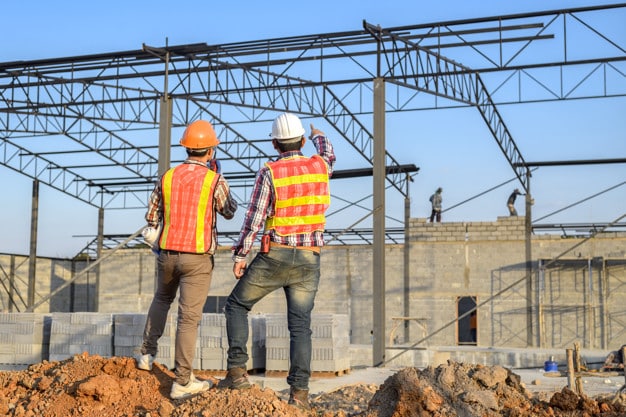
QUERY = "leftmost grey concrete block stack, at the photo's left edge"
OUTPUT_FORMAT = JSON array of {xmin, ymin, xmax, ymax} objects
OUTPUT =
[{"xmin": 0, "ymin": 313, "xmax": 49, "ymax": 370}]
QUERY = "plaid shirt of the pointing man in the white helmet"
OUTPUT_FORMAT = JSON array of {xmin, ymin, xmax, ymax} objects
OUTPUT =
[{"xmin": 232, "ymin": 135, "xmax": 336, "ymax": 262}]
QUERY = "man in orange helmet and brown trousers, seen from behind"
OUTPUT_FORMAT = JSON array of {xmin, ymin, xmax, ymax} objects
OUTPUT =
[{"xmin": 136, "ymin": 120, "xmax": 237, "ymax": 399}]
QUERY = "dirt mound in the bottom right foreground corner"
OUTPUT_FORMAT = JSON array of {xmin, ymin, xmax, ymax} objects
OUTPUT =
[{"xmin": 363, "ymin": 362, "xmax": 626, "ymax": 417}]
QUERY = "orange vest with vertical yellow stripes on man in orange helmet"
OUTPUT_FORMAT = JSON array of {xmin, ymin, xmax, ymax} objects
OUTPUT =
[{"xmin": 159, "ymin": 164, "xmax": 218, "ymax": 253}]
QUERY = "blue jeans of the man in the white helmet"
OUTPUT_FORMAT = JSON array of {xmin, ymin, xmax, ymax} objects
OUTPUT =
[{"xmin": 224, "ymin": 247, "xmax": 320, "ymax": 389}]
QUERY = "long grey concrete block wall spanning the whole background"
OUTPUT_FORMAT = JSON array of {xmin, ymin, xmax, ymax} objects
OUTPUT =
[{"xmin": 0, "ymin": 217, "xmax": 626, "ymax": 349}]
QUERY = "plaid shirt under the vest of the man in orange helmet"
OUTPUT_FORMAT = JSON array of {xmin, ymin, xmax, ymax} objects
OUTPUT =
[{"xmin": 146, "ymin": 159, "xmax": 237, "ymax": 253}]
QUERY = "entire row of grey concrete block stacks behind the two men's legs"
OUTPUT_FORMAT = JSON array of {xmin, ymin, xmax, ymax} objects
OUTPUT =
[{"xmin": 0, "ymin": 313, "xmax": 351, "ymax": 372}]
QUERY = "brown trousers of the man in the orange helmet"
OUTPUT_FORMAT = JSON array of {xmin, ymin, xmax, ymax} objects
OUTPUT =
[{"xmin": 141, "ymin": 251, "xmax": 213, "ymax": 385}]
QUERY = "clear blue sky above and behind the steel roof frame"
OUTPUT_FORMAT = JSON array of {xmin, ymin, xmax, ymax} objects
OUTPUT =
[{"xmin": 0, "ymin": 0, "xmax": 626, "ymax": 257}]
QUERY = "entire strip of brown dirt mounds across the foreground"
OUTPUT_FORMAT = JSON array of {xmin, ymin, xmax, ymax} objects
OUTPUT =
[{"xmin": 0, "ymin": 354, "xmax": 626, "ymax": 417}]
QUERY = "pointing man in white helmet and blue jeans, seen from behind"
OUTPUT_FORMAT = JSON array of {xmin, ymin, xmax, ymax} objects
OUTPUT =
[{"xmin": 218, "ymin": 113, "xmax": 335, "ymax": 409}]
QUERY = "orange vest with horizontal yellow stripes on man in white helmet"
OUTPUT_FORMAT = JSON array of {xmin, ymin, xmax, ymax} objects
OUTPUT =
[{"xmin": 265, "ymin": 155, "xmax": 330, "ymax": 236}]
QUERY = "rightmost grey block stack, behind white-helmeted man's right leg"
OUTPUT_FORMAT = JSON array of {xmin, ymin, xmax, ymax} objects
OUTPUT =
[{"xmin": 265, "ymin": 314, "xmax": 350, "ymax": 373}]
